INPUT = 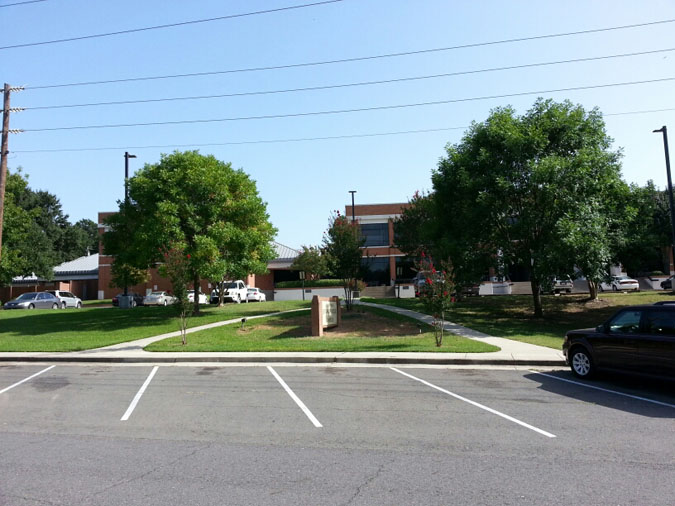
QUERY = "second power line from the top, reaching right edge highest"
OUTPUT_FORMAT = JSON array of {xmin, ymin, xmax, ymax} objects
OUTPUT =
[{"xmin": 23, "ymin": 19, "xmax": 675, "ymax": 90}]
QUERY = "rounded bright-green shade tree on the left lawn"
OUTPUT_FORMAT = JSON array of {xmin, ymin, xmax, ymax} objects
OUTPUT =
[{"xmin": 104, "ymin": 151, "xmax": 276, "ymax": 313}]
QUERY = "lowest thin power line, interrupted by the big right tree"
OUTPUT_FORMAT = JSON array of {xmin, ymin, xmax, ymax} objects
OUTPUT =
[{"xmin": 12, "ymin": 107, "xmax": 675, "ymax": 153}]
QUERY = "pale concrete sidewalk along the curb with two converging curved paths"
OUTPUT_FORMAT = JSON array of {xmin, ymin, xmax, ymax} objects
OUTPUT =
[{"xmin": 0, "ymin": 301, "xmax": 565, "ymax": 366}]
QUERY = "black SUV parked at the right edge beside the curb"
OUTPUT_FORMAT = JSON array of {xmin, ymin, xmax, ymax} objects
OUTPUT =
[{"xmin": 562, "ymin": 304, "xmax": 675, "ymax": 378}]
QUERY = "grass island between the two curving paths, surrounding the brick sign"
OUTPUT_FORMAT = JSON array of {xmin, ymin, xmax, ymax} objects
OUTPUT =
[{"xmin": 145, "ymin": 307, "xmax": 499, "ymax": 353}]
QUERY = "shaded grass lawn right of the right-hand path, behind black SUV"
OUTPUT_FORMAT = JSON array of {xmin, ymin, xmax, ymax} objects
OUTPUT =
[{"xmin": 362, "ymin": 291, "xmax": 674, "ymax": 350}]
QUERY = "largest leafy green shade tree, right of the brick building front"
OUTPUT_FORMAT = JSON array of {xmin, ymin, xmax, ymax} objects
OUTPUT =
[{"xmin": 402, "ymin": 99, "xmax": 626, "ymax": 316}]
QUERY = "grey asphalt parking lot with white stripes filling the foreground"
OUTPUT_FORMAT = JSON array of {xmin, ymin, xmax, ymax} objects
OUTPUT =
[{"xmin": 0, "ymin": 364, "xmax": 675, "ymax": 505}]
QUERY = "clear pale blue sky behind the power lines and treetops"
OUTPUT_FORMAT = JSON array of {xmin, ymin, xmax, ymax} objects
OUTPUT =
[{"xmin": 0, "ymin": 0, "xmax": 675, "ymax": 247}]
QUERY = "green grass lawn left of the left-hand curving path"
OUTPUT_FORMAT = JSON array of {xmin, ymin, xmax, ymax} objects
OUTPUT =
[{"xmin": 0, "ymin": 301, "xmax": 310, "ymax": 351}]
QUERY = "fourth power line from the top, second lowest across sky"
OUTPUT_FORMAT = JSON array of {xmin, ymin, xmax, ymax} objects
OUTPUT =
[{"xmin": 22, "ymin": 77, "xmax": 675, "ymax": 132}]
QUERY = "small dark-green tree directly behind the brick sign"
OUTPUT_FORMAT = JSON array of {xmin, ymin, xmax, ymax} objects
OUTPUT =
[{"xmin": 323, "ymin": 211, "xmax": 366, "ymax": 311}]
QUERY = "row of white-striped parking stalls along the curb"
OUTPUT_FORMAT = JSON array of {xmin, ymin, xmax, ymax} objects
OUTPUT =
[{"xmin": 0, "ymin": 365, "xmax": 675, "ymax": 444}]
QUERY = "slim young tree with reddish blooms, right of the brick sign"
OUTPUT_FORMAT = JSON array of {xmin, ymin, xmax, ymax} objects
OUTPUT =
[{"xmin": 418, "ymin": 255, "xmax": 454, "ymax": 347}]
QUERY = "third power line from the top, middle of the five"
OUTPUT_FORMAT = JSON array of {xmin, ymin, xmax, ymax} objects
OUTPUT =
[{"xmin": 26, "ymin": 48, "xmax": 675, "ymax": 111}]
